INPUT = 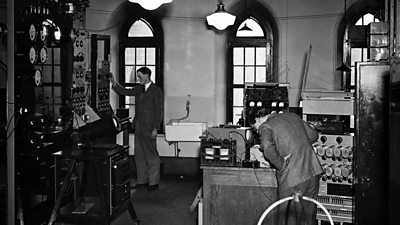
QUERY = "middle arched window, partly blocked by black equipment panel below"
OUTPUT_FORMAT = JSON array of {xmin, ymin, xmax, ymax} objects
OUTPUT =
[{"xmin": 226, "ymin": 14, "xmax": 277, "ymax": 124}]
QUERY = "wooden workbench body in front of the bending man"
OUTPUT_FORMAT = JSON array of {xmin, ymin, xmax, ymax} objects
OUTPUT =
[{"xmin": 201, "ymin": 166, "xmax": 278, "ymax": 225}]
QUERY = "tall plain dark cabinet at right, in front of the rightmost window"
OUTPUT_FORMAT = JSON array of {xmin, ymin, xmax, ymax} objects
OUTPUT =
[{"xmin": 354, "ymin": 62, "xmax": 390, "ymax": 224}]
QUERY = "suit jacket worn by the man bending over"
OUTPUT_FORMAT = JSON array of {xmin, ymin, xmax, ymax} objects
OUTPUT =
[{"xmin": 259, "ymin": 113, "xmax": 323, "ymax": 191}]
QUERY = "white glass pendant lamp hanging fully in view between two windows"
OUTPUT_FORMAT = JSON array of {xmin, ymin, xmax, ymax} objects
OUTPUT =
[{"xmin": 206, "ymin": 2, "xmax": 236, "ymax": 30}]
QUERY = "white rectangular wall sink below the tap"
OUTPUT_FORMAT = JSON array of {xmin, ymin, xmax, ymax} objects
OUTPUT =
[{"xmin": 165, "ymin": 122, "xmax": 207, "ymax": 142}]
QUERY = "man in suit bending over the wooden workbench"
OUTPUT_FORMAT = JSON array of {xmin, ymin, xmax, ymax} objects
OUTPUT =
[{"xmin": 248, "ymin": 109, "xmax": 323, "ymax": 225}]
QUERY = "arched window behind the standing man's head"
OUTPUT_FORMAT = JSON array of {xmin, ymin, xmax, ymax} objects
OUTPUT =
[{"xmin": 119, "ymin": 15, "xmax": 164, "ymax": 130}]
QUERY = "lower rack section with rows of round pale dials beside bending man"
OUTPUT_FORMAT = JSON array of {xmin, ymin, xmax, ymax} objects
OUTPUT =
[{"xmin": 313, "ymin": 134, "xmax": 354, "ymax": 223}]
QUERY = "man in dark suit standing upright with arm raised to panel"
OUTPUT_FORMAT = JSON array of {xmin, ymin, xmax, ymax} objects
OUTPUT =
[{"xmin": 110, "ymin": 67, "xmax": 164, "ymax": 191}]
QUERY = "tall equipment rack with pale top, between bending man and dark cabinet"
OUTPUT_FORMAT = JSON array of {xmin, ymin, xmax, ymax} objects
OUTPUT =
[{"xmin": 303, "ymin": 92, "xmax": 355, "ymax": 225}]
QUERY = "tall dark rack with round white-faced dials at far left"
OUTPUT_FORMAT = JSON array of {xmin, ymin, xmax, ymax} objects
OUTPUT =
[{"xmin": 13, "ymin": 0, "xmax": 62, "ymax": 224}]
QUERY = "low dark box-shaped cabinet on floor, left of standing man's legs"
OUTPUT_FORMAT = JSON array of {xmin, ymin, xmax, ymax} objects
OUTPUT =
[{"xmin": 49, "ymin": 143, "xmax": 136, "ymax": 224}]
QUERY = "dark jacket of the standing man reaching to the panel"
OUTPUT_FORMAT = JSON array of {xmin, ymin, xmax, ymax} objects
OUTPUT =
[{"xmin": 113, "ymin": 83, "xmax": 164, "ymax": 132}]
